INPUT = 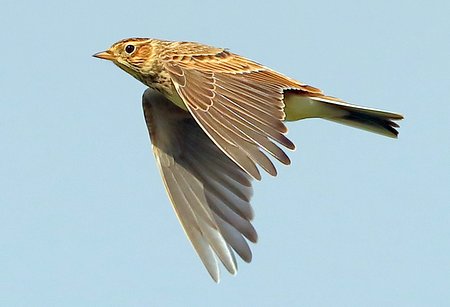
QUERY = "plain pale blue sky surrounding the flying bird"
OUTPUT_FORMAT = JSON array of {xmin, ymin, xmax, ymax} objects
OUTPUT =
[{"xmin": 0, "ymin": 0, "xmax": 450, "ymax": 306}]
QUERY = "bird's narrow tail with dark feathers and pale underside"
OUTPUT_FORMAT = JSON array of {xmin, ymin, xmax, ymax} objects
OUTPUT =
[{"xmin": 284, "ymin": 92, "xmax": 403, "ymax": 138}]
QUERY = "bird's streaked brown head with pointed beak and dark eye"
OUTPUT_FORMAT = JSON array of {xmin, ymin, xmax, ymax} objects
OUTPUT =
[{"xmin": 93, "ymin": 38, "xmax": 160, "ymax": 81}]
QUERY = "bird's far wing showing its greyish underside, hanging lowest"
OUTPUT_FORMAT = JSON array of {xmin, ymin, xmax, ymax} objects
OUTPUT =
[{"xmin": 142, "ymin": 89, "xmax": 257, "ymax": 282}]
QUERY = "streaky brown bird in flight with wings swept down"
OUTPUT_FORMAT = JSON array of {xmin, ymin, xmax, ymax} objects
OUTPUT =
[{"xmin": 93, "ymin": 38, "xmax": 403, "ymax": 282}]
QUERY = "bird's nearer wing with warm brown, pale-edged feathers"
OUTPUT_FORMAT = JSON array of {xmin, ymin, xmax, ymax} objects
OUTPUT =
[{"xmin": 163, "ymin": 48, "xmax": 321, "ymax": 180}]
